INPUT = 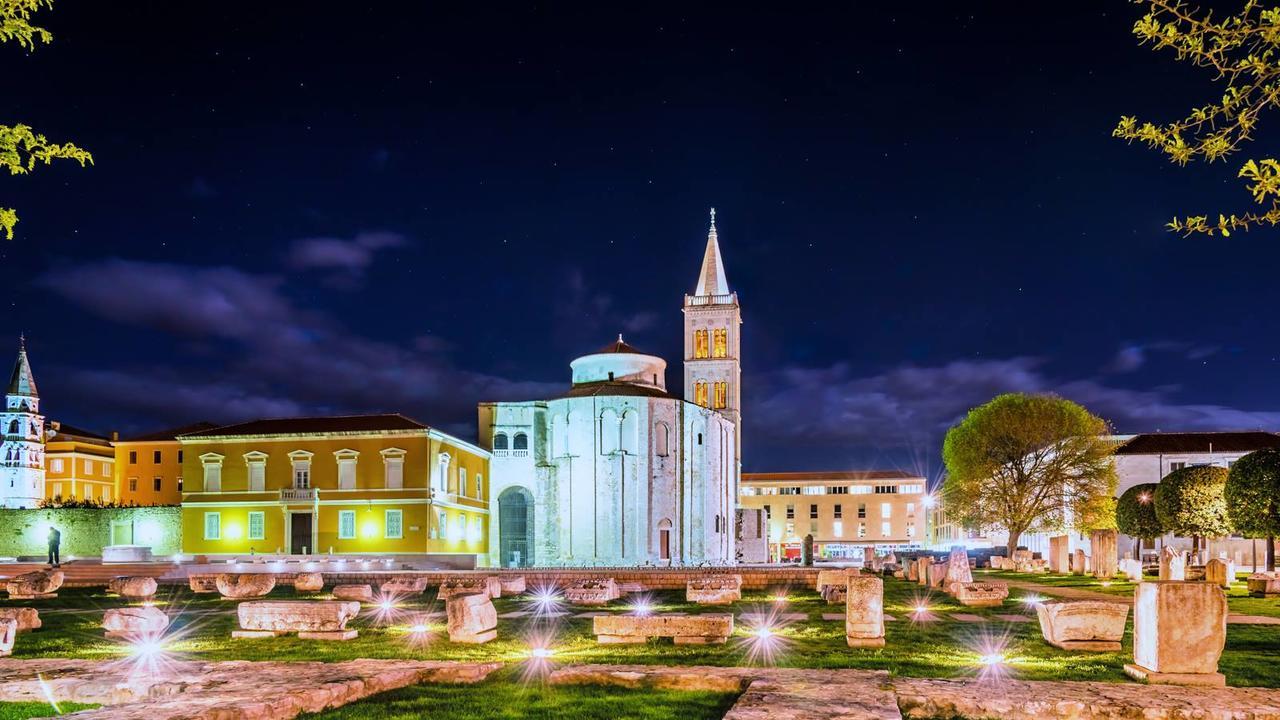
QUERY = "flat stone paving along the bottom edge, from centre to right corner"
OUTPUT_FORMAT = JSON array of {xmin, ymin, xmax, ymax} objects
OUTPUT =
[{"xmin": 549, "ymin": 665, "xmax": 1280, "ymax": 720}]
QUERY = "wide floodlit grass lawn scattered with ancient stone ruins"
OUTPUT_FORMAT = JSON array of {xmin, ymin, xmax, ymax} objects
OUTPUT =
[{"xmin": 3, "ymin": 574, "xmax": 1280, "ymax": 687}]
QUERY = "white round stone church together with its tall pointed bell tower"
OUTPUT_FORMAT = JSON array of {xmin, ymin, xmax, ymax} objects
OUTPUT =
[{"xmin": 479, "ymin": 210, "xmax": 742, "ymax": 568}]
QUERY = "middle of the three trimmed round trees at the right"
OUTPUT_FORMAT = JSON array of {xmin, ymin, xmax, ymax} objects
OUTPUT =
[{"xmin": 1156, "ymin": 465, "xmax": 1231, "ymax": 550}]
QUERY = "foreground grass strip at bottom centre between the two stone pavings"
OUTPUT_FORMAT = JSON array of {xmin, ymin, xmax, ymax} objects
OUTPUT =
[{"xmin": 294, "ymin": 678, "xmax": 737, "ymax": 720}]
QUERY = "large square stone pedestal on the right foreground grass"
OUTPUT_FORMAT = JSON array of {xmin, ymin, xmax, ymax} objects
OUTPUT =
[{"xmin": 1124, "ymin": 582, "xmax": 1226, "ymax": 685}]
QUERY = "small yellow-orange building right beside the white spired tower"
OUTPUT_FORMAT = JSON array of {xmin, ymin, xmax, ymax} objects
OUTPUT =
[{"xmin": 45, "ymin": 420, "xmax": 116, "ymax": 502}]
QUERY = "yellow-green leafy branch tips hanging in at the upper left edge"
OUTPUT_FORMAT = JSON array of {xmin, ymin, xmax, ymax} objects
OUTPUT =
[{"xmin": 0, "ymin": 0, "xmax": 93, "ymax": 240}]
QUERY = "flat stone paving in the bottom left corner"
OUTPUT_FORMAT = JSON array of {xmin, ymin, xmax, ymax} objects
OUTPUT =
[{"xmin": 0, "ymin": 660, "xmax": 502, "ymax": 720}]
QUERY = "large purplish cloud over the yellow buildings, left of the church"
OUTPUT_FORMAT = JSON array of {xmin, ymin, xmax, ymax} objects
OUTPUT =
[{"xmin": 40, "ymin": 260, "xmax": 562, "ymax": 428}]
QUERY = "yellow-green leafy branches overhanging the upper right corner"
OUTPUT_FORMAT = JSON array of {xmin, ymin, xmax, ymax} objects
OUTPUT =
[{"xmin": 1112, "ymin": 0, "xmax": 1280, "ymax": 236}]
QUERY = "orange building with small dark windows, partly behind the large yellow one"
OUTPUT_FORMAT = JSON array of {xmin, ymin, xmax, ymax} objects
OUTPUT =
[{"xmin": 111, "ymin": 423, "xmax": 216, "ymax": 505}]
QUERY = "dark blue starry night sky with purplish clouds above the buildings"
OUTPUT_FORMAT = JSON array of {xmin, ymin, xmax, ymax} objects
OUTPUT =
[{"xmin": 0, "ymin": 0, "xmax": 1280, "ymax": 477}]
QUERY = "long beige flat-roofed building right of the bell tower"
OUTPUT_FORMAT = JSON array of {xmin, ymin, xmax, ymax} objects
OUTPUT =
[{"xmin": 739, "ymin": 470, "xmax": 928, "ymax": 561}]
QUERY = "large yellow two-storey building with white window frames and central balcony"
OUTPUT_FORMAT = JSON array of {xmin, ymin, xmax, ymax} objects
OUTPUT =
[{"xmin": 178, "ymin": 415, "xmax": 489, "ymax": 564}]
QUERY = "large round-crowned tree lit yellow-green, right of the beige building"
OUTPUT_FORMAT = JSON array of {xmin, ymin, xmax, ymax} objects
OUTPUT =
[{"xmin": 942, "ymin": 393, "xmax": 1116, "ymax": 557}]
